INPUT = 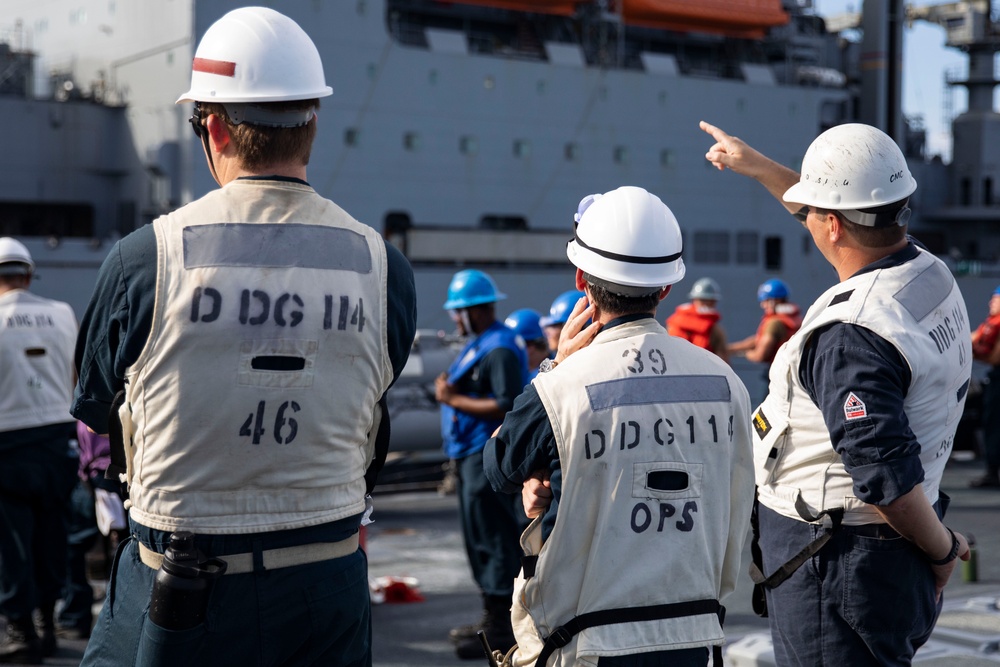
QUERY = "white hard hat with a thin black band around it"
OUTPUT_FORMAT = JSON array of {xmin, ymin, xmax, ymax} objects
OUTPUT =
[{"xmin": 566, "ymin": 186, "xmax": 684, "ymax": 295}]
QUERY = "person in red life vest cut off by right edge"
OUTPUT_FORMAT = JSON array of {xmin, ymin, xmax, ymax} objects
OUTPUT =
[{"xmin": 969, "ymin": 287, "xmax": 1000, "ymax": 488}]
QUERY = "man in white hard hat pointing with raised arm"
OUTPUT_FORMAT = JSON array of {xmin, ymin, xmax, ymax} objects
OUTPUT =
[{"xmin": 701, "ymin": 117, "xmax": 972, "ymax": 665}]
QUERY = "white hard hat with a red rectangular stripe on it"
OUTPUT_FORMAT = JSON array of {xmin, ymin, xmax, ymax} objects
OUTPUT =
[{"xmin": 177, "ymin": 7, "xmax": 333, "ymax": 103}]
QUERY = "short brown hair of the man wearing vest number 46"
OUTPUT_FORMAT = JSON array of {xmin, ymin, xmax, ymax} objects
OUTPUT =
[{"xmin": 200, "ymin": 99, "xmax": 319, "ymax": 172}]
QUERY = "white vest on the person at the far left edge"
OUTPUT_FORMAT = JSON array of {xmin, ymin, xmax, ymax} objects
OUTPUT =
[{"xmin": 0, "ymin": 289, "xmax": 76, "ymax": 432}]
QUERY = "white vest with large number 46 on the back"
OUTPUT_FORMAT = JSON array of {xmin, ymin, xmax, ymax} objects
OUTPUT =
[{"xmin": 120, "ymin": 180, "xmax": 392, "ymax": 534}]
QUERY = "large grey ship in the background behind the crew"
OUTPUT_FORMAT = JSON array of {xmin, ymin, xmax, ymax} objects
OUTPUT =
[{"xmin": 0, "ymin": 0, "xmax": 1000, "ymax": 396}]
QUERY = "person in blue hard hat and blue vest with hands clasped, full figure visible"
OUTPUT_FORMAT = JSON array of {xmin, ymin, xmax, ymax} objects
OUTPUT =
[{"xmin": 435, "ymin": 269, "xmax": 528, "ymax": 659}]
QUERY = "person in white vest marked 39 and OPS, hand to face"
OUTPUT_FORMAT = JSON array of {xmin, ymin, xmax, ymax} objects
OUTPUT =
[{"xmin": 484, "ymin": 187, "xmax": 753, "ymax": 667}]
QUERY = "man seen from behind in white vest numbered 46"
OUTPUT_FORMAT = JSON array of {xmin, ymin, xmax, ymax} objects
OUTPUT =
[{"xmin": 74, "ymin": 7, "xmax": 415, "ymax": 665}]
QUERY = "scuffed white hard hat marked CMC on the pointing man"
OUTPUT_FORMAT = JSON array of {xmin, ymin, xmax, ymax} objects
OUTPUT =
[{"xmin": 783, "ymin": 123, "xmax": 917, "ymax": 226}]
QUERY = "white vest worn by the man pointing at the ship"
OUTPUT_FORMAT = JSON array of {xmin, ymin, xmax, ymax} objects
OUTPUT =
[{"xmin": 753, "ymin": 251, "xmax": 972, "ymax": 525}]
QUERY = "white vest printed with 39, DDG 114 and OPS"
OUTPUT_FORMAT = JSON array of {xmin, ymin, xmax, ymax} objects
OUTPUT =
[{"xmin": 512, "ymin": 319, "xmax": 753, "ymax": 667}]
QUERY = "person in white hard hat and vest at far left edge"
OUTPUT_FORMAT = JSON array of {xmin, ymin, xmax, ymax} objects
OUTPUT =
[{"xmin": 0, "ymin": 236, "xmax": 78, "ymax": 664}]
